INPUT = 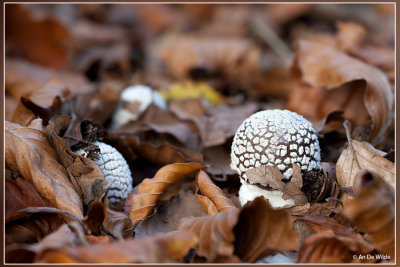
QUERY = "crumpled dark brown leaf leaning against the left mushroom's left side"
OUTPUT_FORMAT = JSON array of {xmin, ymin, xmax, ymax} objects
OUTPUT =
[{"xmin": 45, "ymin": 115, "xmax": 110, "ymax": 207}]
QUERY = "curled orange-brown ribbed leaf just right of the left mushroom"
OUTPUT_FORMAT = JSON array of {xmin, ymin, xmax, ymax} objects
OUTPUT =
[{"xmin": 129, "ymin": 163, "xmax": 204, "ymax": 227}]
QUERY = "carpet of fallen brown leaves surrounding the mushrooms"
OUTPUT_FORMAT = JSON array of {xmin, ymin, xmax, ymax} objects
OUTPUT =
[{"xmin": 4, "ymin": 3, "xmax": 396, "ymax": 264}]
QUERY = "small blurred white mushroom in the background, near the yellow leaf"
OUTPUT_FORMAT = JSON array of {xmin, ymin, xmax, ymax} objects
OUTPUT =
[{"xmin": 110, "ymin": 85, "xmax": 167, "ymax": 131}]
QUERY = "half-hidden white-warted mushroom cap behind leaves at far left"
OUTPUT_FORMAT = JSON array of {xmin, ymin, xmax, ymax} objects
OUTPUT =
[{"xmin": 74, "ymin": 141, "xmax": 132, "ymax": 207}]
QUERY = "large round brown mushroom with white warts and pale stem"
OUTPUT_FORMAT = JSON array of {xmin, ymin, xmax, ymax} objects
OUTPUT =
[{"xmin": 231, "ymin": 109, "xmax": 321, "ymax": 208}]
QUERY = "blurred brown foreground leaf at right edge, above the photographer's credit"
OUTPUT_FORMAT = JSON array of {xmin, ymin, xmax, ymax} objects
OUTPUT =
[{"xmin": 343, "ymin": 170, "xmax": 395, "ymax": 260}]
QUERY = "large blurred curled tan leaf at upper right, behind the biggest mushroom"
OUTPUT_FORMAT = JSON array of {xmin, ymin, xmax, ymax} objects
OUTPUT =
[{"xmin": 288, "ymin": 41, "xmax": 394, "ymax": 143}]
